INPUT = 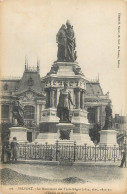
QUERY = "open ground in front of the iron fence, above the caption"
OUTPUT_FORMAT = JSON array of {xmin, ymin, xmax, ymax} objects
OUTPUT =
[{"xmin": 1, "ymin": 163, "xmax": 127, "ymax": 184}]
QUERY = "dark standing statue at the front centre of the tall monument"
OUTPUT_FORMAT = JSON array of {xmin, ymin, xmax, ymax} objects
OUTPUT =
[{"xmin": 57, "ymin": 82, "xmax": 74, "ymax": 123}]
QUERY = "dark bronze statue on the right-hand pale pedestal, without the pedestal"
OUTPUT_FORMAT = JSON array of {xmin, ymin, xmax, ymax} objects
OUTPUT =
[{"xmin": 103, "ymin": 102, "xmax": 113, "ymax": 130}]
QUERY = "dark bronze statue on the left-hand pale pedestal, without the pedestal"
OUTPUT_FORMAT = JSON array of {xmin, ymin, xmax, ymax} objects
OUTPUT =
[{"xmin": 12, "ymin": 98, "xmax": 24, "ymax": 126}]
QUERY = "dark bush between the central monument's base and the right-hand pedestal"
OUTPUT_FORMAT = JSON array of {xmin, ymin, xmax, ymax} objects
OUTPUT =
[{"xmin": 89, "ymin": 123, "xmax": 101, "ymax": 143}]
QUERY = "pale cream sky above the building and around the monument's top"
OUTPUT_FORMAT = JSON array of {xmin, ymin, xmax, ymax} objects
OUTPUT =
[{"xmin": 0, "ymin": 0, "xmax": 127, "ymax": 114}]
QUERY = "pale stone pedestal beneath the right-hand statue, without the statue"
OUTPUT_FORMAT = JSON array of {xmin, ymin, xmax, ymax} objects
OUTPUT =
[{"xmin": 99, "ymin": 129, "xmax": 118, "ymax": 147}]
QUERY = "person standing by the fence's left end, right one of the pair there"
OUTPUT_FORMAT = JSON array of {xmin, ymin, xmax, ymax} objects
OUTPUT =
[{"xmin": 11, "ymin": 137, "xmax": 18, "ymax": 163}]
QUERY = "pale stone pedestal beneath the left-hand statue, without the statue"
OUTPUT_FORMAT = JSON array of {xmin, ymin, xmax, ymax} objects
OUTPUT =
[{"xmin": 9, "ymin": 127, "xmax": 28, "ymax": 143}]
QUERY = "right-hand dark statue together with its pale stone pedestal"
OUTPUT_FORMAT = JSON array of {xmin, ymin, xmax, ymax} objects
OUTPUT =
[{"xmin": 99, "ymin": 102, "xmax": 118, "ymax": 147}]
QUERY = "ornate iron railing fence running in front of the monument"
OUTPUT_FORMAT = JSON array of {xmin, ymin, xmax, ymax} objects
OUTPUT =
[{"xmin": 18, "ymin": 143, "xmax": 122, "ymax": 162}]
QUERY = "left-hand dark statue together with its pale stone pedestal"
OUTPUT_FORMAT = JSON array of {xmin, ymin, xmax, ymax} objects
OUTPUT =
[{"xmin": 9, "ymin": 97, "xmax": 27, "ymax": 143}]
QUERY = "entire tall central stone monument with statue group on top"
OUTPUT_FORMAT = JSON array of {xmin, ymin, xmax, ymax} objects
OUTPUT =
[{"xmin": 35, "ymin": 21, "xmax": 93, "ymax": 145}]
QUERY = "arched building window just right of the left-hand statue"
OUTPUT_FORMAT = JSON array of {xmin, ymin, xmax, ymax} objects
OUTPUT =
[{"xmin": 24, "ymin": 106, "xmax": 35, "ymax": 119}]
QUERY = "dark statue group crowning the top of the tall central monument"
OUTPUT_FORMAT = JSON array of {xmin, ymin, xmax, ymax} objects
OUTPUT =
[{"xmin": 56, "ymin": 20, "xmax": 77, "ymax": 62}]
